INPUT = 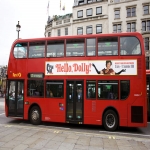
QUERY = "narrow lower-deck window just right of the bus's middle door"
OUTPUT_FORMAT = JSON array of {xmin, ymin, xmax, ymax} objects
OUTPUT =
[{"xmin": 86, "ymin": 81, "xmax": 96, "ymax": 99}]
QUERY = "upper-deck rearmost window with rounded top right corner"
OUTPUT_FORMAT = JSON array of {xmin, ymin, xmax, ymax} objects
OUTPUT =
[{"xmin": 120, "ymin": 37, "xmax": 141, "ymax": 55}]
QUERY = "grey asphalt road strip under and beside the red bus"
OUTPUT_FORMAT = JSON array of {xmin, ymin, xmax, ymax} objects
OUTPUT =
[{"xmin": 0, "ymin": 98, "xmax": 150, "ymax": 138}]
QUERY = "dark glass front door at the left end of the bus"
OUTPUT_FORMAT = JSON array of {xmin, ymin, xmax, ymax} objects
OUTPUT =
[{"xmin": 6, "ymin": 80, "xmax": 24, "ymax": 118}]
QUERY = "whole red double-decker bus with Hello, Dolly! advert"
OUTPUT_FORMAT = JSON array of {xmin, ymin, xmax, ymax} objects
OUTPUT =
[{"xmin": 5, "ymin": 33, "xmax": 147, "ymax": 131}]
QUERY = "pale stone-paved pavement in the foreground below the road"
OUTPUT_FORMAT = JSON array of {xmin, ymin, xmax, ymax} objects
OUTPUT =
[{"xmin": 0, "ymin": 124, "xmax": 150, "ymax": 150}]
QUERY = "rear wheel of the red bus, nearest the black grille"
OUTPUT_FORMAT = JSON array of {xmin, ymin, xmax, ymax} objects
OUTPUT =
[{"xmin": 103, "ymin": 109, "xmax": 118, "ymax": 131}]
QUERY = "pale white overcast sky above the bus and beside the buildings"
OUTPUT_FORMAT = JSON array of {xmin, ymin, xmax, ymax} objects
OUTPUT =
[{"xmin": 0, "ymin": 0, "xmax": 74, "ymax": 66}]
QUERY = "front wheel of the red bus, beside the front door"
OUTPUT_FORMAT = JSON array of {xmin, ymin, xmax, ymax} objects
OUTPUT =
[{"xmin": 30, "ymin": 106, "xmax": 41, "ymax": 125}]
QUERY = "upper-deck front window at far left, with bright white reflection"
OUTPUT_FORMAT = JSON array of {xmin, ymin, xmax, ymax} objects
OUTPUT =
[{"xmin": 14, "ymin": 43, "xmax": 27, "ymax": 58}]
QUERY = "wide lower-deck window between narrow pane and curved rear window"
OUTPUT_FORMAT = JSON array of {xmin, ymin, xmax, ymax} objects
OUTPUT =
[{"xmin": 98, "ymin": 81, "xmax": 119, "ymax": 99}]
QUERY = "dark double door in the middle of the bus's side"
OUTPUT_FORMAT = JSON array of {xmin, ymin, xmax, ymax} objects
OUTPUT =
[{"xmin": 66, "ymin": 81, "xmax": 83, "ymax": 124}]
